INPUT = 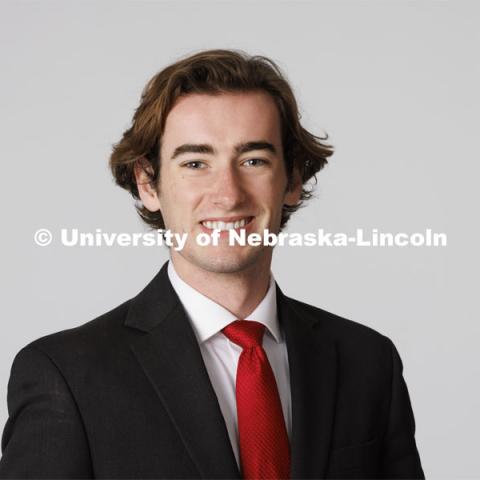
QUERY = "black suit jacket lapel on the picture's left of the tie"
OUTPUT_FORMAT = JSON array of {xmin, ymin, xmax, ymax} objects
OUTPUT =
[{"xmin": 125, "ymin": 263, "xmax": 240, "ymax": 478}]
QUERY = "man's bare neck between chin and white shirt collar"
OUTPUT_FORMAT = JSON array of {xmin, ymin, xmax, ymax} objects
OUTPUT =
[{"xmin": 170, "ymin": 252, "xmax": 272, "ymax": 319}]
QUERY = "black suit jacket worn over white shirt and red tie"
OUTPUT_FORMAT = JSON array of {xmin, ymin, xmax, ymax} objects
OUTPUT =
[{"xmin": 0, "ymin": 264, "xmax": 423, "ymax": 479}]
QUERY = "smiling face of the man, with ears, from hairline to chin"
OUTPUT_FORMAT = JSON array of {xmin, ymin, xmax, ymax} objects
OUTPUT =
[{"xmin": 136, "ymin": 92, "xmax": 301, "ymax": 273}]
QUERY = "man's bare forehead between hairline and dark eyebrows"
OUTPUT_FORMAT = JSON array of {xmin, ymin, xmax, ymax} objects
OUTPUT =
[{"xmin": 162, "ymin": 91, "xmax": 281, "ymax": 149}]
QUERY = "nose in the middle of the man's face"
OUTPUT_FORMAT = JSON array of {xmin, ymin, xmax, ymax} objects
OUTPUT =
[{"xmin": 211, "ymin": 165, "xmax": 246, "ymax": 211}]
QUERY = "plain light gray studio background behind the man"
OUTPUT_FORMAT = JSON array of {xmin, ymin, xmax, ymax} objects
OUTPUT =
[{"xmin": 0, "ymin": 0, "xmax": 480, "ymax": 478}]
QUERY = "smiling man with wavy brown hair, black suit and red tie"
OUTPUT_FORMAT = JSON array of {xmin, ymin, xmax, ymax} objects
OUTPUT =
[{"xmin": 0, "ymin": 50, "xmax": 423, "ymax": 479}]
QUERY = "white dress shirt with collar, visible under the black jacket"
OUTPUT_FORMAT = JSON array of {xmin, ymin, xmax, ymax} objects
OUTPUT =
[{"xmin": 168, "ymin": 260, "xmax": 292, "ymax": 467}]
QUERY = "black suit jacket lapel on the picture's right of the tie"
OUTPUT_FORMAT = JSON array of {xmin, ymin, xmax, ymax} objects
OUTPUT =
[{"xmin": 277, "ymin": 286, "xmax": 337, "ymax": 478}]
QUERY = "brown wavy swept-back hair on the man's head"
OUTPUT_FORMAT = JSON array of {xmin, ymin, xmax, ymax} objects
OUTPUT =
[{"xmin": 110, "ymin": 50, "xmax": 333, "ymax": 229}]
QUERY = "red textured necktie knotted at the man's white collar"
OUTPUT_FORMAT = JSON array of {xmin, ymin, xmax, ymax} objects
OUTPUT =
[{"xmin": 222, "ymin": 320, "xmax": 290, "ymax": 480}]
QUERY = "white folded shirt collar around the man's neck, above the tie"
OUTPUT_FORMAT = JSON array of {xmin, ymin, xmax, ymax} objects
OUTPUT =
[{"xmin": 168, "ymin": 260, "xmax": 282, "ymax": 343}]
